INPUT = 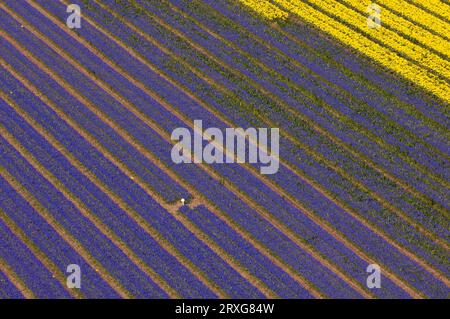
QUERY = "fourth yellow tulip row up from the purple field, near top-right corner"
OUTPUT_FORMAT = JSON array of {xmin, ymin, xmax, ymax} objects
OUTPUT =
[{"xmin": 373, "ymin": 0, "xmax": 450, "ymax": 38}]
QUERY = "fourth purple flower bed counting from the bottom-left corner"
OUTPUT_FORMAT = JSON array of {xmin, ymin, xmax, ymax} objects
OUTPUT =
[{"xmin": 0, "ymin": 138, "xmax": 182, "ymax": 298}]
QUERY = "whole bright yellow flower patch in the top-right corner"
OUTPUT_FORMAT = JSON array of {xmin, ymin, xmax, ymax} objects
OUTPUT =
[{"xmin": 239, "ymin": 0, "xmax": 450, "ymax": 102}]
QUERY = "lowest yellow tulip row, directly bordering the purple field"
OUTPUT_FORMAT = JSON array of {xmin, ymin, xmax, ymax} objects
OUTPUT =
[{"xmin": 273, "ymin": 0, "xmax": 450, "ymax": 103}]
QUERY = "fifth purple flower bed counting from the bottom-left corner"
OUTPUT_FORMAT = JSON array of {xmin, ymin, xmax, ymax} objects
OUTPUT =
[{"xmin": 0, "ymin": 74, "xmax": 220, "ymax": 294}]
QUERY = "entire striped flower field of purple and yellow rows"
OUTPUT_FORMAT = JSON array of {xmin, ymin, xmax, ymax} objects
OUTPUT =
[{"xmin": 0, "ymin": 0, "xmax": 450, "ymax": 298}]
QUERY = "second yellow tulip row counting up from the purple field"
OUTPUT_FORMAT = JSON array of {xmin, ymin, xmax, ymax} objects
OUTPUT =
[{"xmin": 302, "ymin": 0, "xmax": 450, "ymax": 79}]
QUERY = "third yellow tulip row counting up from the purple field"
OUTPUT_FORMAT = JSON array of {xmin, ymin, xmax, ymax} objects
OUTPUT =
[{"xmin": 341, "ymin": 0, "xmax": 450, "ymax": 56}]
